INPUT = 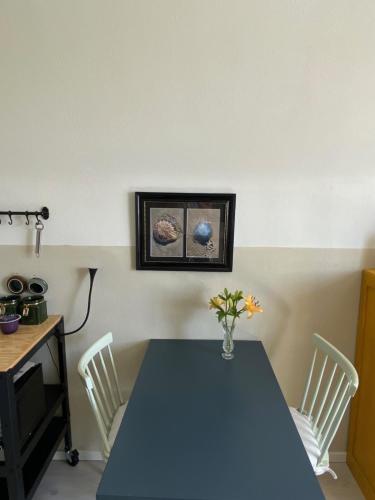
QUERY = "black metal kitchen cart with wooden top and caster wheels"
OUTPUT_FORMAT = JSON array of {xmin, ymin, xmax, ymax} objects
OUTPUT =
[{"xmin": 0, "ymin": 316, "xmax": 79, "ymax": 500}]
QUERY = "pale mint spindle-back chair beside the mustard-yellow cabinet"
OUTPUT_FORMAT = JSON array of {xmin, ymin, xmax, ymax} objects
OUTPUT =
[{"xmin": 290, "ymin": 333, "xmax": 359, "ymax": 479}]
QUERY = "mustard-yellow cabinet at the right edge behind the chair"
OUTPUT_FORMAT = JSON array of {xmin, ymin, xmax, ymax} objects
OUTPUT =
[{"xmin": 347, "ymin": 269, "xmax": 375, "ymax": 500}]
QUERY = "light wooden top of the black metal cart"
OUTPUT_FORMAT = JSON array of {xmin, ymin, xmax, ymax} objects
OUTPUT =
[{"xmin": 0, "ymin": 315, "xmax": 61, "ymax": 372}]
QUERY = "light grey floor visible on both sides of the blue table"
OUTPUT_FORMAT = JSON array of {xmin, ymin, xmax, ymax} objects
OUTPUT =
[{"xmin": 34, "ymin": 461, "xmax": 364, "ymax": 500}]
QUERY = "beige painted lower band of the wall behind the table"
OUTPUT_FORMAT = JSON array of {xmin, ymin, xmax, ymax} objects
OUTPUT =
[{"xmin": 0, "ymin": 246, "xmax": 375, "ymax": 450}]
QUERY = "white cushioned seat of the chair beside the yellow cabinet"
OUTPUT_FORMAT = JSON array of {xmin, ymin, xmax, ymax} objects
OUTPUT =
[{"xmin": 289, "ymin": 407, "xmax": 332, "ymax": 476}]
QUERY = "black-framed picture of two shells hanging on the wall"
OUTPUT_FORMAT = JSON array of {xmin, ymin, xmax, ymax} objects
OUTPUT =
[{"xmin": 135, "ymin": 192, "xmax": 236, "ymax": 271}]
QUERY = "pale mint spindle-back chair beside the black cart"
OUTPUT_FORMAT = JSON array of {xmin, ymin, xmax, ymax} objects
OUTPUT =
[{"xmin": 78, "ymin": 333, "xmax": 127, "ymax": 460}]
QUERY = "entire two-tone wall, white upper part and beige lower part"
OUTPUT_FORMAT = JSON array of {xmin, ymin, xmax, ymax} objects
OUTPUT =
[{"xmin": 0, "ymin": 0, "xmax": 375, "ymax": 451}]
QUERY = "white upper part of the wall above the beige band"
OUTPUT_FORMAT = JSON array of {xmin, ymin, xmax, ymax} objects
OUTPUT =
[{"xmin": 0, "ymin": 0, "xmax": 375, "ymax": 248}]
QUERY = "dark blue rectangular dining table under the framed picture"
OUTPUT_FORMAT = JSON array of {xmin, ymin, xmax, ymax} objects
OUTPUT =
[{"xmin": 96, "ymin": 340, "xmax": 324, "ymax": 500}]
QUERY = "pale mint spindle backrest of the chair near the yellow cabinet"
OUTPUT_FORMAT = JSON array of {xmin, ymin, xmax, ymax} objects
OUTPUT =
[{"xmin": 299, "ymin": 333, "xmax": 359, "ymax": 465}]
